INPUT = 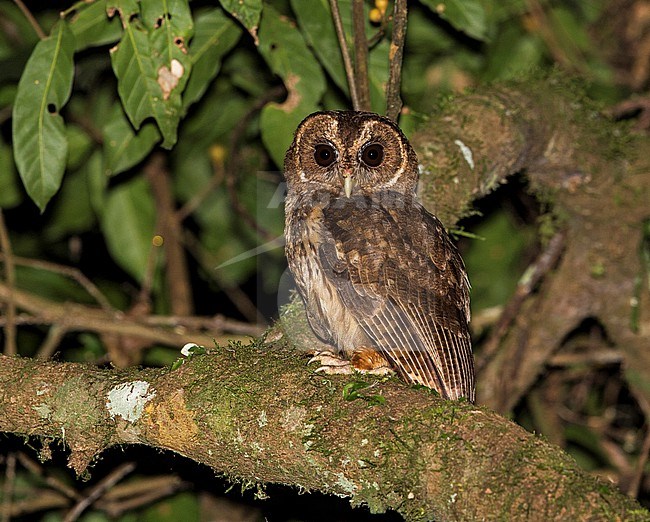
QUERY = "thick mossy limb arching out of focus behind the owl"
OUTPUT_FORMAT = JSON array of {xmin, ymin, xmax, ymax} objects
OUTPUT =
[{"xmin": 412, "ymin": 79, "xmax": 650, "ymax": 417}]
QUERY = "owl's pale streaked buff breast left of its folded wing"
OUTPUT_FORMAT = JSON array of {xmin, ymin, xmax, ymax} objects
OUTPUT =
[{"xmin": 285, "ymin": 197, "xmax": 369, "ymax": 355}]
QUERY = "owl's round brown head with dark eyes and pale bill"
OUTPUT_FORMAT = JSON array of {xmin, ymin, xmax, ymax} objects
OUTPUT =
[{"xmin": 284, "ymin": 111, "xmax": 418, "ymax": 197}]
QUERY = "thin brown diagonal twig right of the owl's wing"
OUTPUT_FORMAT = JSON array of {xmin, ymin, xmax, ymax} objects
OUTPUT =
[{"xmin": 476, "ymin": 231, "xmax": 566, "ymax": 373}]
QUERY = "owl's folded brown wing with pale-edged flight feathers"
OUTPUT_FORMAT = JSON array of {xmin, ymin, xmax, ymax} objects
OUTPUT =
[{"xmin": 319, "ymin": 196, "xmax": 474, "ymax": 401}]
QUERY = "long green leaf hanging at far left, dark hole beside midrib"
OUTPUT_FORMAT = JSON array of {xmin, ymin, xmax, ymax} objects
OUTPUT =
[{"xmin": 13, "ymin": 21, "xmax": 74, "ymax": 212}]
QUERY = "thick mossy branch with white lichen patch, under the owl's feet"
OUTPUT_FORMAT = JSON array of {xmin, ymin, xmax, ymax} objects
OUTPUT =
[{"xmin": 0, "ymin": 343, "xmax": 642, "ymax": 520}]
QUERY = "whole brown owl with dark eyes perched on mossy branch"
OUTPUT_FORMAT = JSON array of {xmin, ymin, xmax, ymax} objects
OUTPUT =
[{"xmin": 284, "ymin": 111, "xmax": 474, "ymax": 401}]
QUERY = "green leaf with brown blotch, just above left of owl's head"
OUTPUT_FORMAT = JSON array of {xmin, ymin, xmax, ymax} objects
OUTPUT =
[{"xmin": 254, "ymin": 5, "xmax": 325, "ymax": 166}]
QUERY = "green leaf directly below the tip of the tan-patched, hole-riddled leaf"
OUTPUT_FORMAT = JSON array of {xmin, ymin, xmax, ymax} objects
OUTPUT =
[{"xmin": 103, "ymin": 105, "xmax": 160, "ymax": 176}]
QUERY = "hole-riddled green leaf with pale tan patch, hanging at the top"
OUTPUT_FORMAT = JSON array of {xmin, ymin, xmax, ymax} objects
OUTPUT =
[{"xmin": 107, "ymin": 0, "xmax": 193, "ymax": 148}]
